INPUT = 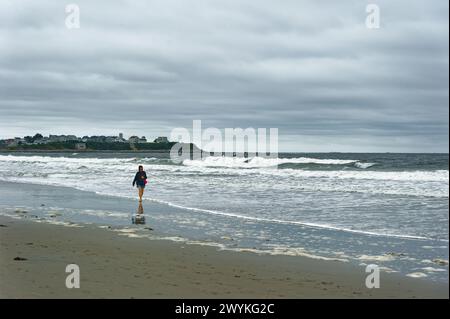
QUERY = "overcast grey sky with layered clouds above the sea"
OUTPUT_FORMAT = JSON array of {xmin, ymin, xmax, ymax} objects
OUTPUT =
[{"xmin": 0, "ymin": 0, "xmax": 449, "ymax": 152}]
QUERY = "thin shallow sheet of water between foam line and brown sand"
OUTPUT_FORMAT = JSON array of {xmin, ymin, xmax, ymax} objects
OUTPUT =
[{"xmin": 0, "ymin": 176, "xmax": 448, "ymax": 282}]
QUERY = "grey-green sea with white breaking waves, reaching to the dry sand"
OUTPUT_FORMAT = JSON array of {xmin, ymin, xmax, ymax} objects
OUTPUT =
[{"xmin": 0, "ymin": 152, "xmax": 449, "ymax": 282}]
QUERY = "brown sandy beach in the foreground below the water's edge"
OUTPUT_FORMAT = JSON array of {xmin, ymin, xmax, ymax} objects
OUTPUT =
[{"xmin": 0, "ymin": 216, "xmax": 448, "ymax": 298}]
